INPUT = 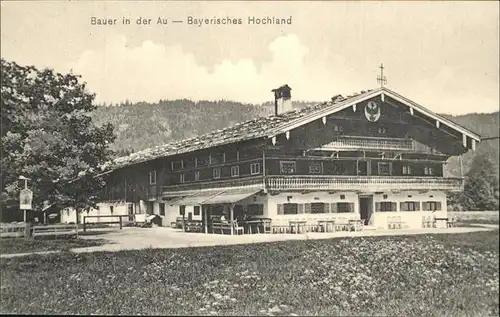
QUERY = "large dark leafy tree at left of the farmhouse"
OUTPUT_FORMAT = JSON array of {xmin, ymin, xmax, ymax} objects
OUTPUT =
[{"xmin": 1, "ymin": 59, "xmax": 115, "ymax": 223}]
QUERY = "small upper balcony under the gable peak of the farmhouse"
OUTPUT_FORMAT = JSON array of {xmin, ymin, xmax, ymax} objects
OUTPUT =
[{"xmin": 323, "ymin": 136, "xmax": 434, "ymax": 153}]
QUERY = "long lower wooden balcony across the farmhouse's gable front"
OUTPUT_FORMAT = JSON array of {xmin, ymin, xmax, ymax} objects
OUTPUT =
[{"xmin": 266, "ymin": 175, "xmax": 463, "ymax": 192}]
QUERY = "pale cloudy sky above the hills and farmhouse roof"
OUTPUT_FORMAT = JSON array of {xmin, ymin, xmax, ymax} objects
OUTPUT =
[{"xmin": 1, "ymin": 1, "xmax": 500, "ymax": 115}]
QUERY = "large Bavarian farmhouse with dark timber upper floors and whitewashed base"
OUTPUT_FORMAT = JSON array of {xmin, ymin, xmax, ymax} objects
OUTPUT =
[{"xmin": 62, "ymin": 85, "xmax": 480, "ymax": 232}]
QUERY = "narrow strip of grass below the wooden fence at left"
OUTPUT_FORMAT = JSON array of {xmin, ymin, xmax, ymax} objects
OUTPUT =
[{"xmin": 0, "ymin": 238, "xmax": 106, "ymax": 254}]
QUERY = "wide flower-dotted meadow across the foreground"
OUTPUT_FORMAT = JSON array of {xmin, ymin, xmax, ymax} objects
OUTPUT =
[{"xmin": 0, "ymin": 230, "xmax": 499, "ymax": 316}]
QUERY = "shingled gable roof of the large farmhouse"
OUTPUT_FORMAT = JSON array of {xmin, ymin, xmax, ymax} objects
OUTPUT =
[{"xmin": 101, "ymin": 87, "xmax": 479, "ymax": 172}]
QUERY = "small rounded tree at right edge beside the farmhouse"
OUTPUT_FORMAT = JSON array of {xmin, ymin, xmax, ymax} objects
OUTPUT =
[{"xmin": 460, "ymin": 154, "xmax": 499, "ymax": 210}]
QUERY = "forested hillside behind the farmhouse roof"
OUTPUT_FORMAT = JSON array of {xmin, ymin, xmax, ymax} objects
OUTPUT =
[{"xmin": 89, "ymin": 99, "xmax": 499, "ymax": 176}]
